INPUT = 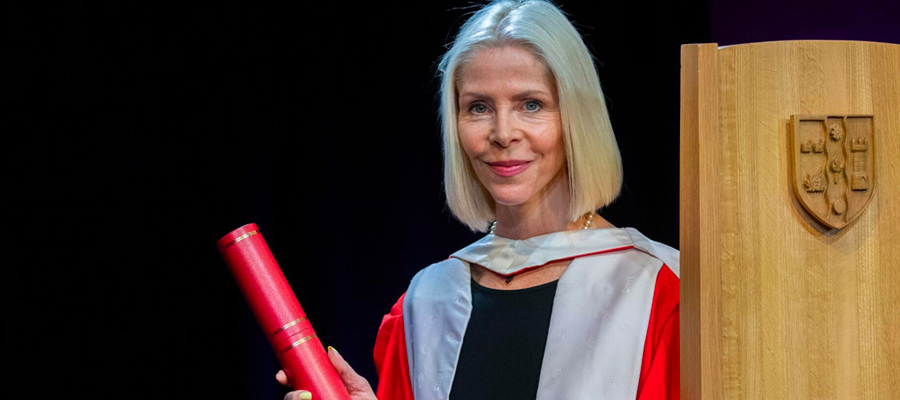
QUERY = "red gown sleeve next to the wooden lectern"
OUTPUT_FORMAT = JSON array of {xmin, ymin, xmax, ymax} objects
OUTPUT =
[{"xmin": 637, "ymin": 265, "xmax": 681, "ymax": 400}]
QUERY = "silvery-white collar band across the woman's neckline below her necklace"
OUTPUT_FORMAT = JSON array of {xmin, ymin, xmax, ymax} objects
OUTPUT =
[{"xmin": 450, "ymin": 228, "xmax": 643, "ymax": 277}]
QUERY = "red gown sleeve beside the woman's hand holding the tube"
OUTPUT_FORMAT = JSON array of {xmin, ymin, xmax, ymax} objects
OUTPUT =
[{"xmin": 373, "ymin": 293, "xmax": 413, "ymax": 400}]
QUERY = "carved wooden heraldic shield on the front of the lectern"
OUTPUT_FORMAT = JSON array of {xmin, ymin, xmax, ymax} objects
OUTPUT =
[{"xmin": 791, "ymin": 115, "xmax": 875, "ymax": 229}]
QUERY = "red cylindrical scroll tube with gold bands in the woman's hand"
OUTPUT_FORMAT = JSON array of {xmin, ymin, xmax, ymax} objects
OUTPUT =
[{"xmin": 216, "ymin": 224, "xmax": 350, "ymax": 400}]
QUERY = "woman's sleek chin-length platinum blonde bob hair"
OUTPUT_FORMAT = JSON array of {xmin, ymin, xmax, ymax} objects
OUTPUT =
[{"xmin": 438, "ymin": 0, "xmax": 622, "ymax": 232}]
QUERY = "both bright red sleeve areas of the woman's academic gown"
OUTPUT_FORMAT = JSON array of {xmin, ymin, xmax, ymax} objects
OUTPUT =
[{"xmin": 374, "ymin": 265, "xmax": 680, "ymax": 400}]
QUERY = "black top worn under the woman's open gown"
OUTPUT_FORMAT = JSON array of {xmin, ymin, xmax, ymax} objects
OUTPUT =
[{"xmin": 450, "ymin": 279, "xmax": 559, "ymax": 400}]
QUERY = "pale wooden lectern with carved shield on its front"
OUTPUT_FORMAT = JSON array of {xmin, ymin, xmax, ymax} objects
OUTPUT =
[{"xmin": 680, "ymin": 41, "xmax": 900, "ymax": 400}]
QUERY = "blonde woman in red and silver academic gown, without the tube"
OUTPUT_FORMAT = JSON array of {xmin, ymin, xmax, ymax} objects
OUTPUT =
[{"xmin": 278, "ymin": 1, "xmax": 679, "ymax": 400}]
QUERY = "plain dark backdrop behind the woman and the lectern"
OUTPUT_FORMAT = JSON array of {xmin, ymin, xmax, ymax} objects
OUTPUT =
[{"xmin": 0, "ymin": 0, "xmax": 900, "ymax": 399}]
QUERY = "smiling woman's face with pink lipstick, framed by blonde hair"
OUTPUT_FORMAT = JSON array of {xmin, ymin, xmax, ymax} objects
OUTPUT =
[{"xmin": 457, "ymin": 46, "xmax": 566, "ymax": 206}]
